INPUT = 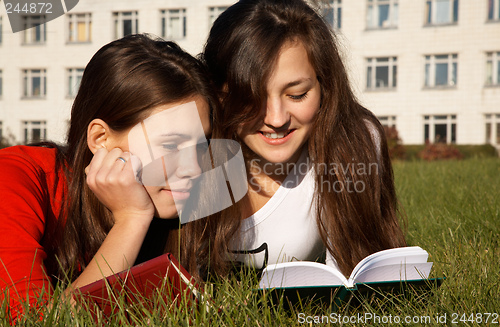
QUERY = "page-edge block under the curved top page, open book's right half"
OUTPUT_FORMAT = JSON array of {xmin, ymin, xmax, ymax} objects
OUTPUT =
[{"xmin": 349, "ymin": 262, "xmax": 432, "ymax": 285}]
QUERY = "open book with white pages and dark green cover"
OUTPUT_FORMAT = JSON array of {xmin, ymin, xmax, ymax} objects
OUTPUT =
[{"xmin": 259, "ymin": 246, "xmax": 441, "ymax": 308}]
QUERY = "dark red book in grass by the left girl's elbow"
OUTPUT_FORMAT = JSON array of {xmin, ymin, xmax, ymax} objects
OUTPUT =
[{"xmin": 74, "ymin": 253, "xmax": 202, "ymax": 316}]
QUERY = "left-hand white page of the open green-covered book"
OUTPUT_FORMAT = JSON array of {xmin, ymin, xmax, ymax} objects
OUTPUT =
[{"xmin": 259, "ymin": 261, "xmax": 347, "ymax": 288}]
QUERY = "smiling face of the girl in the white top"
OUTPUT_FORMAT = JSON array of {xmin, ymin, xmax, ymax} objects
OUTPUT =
[{"xmin": 238, "ymin": 42, "xmax": 321, "ymax": 168}]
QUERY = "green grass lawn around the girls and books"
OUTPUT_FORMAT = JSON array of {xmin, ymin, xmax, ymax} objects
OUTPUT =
[{"xmin": 0, "ymin": 159, "xmax": 500, "ymax": 326}]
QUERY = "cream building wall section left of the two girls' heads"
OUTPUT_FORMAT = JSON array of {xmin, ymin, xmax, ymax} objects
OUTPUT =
[{"xmin": 0, "ymin": 0, "xmax": 233, "ymax": 142}]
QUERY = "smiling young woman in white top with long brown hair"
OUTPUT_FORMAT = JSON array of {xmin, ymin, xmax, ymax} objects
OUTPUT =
[{"xmin": 186, "ymin": 0, "xmax": 405, "ymax": 275}]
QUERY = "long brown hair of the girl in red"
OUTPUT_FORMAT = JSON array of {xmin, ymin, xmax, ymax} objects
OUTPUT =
[{"xmin": 47, "ymin": 35, "xmax": 217, "ymax": 279}]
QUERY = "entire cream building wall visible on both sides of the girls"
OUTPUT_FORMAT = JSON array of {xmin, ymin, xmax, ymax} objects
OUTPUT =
[{"xmin": 0, "ymin": 0, "xmax": 500, "ymax": 144}]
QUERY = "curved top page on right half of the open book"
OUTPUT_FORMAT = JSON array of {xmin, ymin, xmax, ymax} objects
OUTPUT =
[{"xmin": 350, "ymin": 246, "xmax": 429, "ymax": 279}]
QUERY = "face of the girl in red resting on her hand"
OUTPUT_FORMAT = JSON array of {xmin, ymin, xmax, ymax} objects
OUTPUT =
[{"xmin": 114, "ymin": 96, "xmax": 211, "ymax": 219}]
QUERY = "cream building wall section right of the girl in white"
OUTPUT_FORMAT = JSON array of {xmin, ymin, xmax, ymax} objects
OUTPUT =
[{"xmin": 339, "ymin": 0, "xmax": 500, "ymax": 144}]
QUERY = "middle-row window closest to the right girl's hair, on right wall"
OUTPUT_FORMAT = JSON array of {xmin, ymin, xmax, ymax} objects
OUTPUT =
[{"xmin": 366, "ymin": 56, "xmax": 398, "ymax": 91}]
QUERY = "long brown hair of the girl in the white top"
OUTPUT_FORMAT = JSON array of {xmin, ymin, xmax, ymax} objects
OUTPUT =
[{"xmin": 198, "ymin": 0, "xmax": 405, "ymax": 275}]
